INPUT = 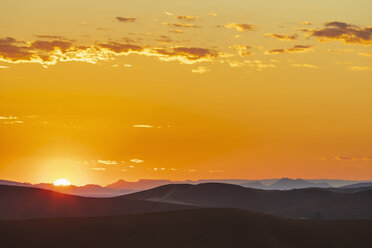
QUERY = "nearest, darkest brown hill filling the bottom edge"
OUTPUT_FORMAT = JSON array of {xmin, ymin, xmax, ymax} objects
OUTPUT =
[{"xmin": 0, "ymin": 209, "xmax": 372, "ymax": 248}]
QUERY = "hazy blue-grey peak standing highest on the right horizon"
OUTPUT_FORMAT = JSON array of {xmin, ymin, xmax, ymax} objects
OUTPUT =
[{"xmin": 267, "ymin": 178, "xmax": 331, "ymax": 190}]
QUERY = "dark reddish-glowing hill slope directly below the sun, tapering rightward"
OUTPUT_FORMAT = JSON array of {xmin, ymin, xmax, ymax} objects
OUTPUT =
[{"xmin": 0, "ymin": 185, "xmax": 196, "ymax": 220}]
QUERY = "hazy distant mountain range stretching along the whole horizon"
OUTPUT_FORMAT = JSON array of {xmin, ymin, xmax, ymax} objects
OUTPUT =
[{"xmin": 0, "ymin": 178, "xmax": 372, "ymax": 197}]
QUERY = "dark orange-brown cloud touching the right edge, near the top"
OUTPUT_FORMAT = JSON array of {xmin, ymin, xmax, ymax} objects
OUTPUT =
[{"xmin": 307, "ymin": 21, "xmax": 372, "ymax": 45}]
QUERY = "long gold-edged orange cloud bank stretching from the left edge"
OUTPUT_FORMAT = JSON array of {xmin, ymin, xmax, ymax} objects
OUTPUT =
[{"xmin": 0, "ymin": 36, "xmax": 220, "ymax": 66}]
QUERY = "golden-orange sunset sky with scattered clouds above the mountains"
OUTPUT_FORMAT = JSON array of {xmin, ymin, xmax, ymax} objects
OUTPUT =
[{"xmin": 0, "ymin": 0, "xmax": 372, "ymax": 185}]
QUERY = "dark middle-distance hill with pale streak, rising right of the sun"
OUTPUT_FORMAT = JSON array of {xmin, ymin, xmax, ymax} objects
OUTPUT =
[{"xmin": 120, "ymin": 183, "xmax": 372, "ymax": 219}]
